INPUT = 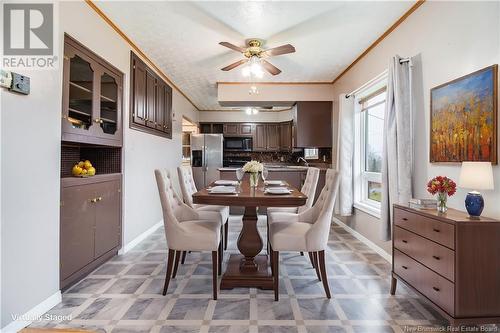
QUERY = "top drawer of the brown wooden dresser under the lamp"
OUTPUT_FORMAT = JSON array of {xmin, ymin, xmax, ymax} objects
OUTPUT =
[{"xmin": 394, "ymin": 208, "xmax": 455, "ymax": 249}]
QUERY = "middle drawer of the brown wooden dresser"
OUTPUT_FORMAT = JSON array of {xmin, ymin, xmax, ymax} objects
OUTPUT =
[{"xmin": 394, "ymin": 227, "xmax": 455, "ymax": 281}]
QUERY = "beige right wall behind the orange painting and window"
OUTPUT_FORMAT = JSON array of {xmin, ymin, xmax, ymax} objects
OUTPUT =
[{"xmin": 333, "ymin": 1, "xmax": 500, "ymax": 254}]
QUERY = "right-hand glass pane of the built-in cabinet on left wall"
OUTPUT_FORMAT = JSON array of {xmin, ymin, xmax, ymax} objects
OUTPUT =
[{"xmin": 98, "ymin": 73, "xmax": 119, "ymax": 135}]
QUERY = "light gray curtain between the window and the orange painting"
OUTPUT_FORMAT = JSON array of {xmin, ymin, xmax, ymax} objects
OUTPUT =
[{"xmin": 381, "ymin": 56, "xmax": 413, "ymax": 240}]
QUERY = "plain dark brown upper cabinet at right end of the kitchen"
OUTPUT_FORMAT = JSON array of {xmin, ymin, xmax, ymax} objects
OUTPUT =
[{"xmin": 294, "ymin": 102, "xmax": 333, "ymax": 148}]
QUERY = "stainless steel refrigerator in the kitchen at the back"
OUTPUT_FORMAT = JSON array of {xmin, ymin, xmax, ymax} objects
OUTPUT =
[{"xmin": 191, "ymin": 134, "xmax": 223, "ymax": 189}]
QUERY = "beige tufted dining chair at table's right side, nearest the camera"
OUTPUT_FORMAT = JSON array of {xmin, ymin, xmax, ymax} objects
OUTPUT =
[{"xmin": 269, "ymin": 169, "xmax": 340, "ymax": 301}]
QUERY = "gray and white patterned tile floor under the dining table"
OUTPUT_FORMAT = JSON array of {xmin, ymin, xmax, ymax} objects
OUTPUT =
[{"xmin": 33, "ymin": 217, "xmax": 496, "ymax": 333}]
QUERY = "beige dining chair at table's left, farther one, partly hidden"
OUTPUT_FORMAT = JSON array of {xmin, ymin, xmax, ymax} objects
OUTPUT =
[{"xmin": 177, "ymin": 166, "xmax": 229, "ymax": 263}]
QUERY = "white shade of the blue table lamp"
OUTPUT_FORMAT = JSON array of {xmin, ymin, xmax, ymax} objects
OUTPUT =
[{"xmin": 458, "ymin": 162, "xmax": 494, "ymax": 190}]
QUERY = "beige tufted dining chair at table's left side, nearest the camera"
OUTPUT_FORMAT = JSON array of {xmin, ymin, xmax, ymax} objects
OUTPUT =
[{"xmin": 155, "ymin": 170, "xmax": 222, "ymax": 300}]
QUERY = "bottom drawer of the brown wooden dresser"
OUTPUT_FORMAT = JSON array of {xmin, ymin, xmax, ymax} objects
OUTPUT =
[{"xmin": 393, "ymin": 249, "xmax": 455, "ymax": 316}]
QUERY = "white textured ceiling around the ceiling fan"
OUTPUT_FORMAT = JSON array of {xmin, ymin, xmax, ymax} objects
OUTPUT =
[{"xmin": 96, "ymin": 1, "xmax": 414, "ymax": 110}]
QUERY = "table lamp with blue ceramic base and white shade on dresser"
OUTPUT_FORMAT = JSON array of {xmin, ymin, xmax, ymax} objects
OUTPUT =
[{"xmin": 458, "ymin": 162, "xmax": 494, "ymax": 219}]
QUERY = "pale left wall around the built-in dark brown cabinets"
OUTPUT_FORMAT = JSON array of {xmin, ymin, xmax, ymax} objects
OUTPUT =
[{"xmin": 0, "ymin": 1, "xmax": 198, "ymax": 327}]
